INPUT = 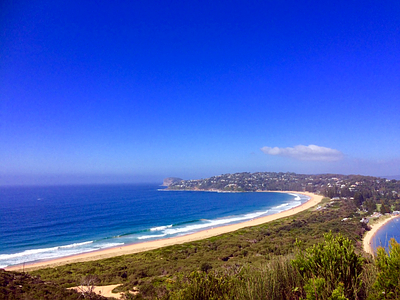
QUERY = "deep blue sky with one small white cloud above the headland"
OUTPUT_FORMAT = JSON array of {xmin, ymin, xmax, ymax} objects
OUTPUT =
[{"xmin": 0, "ymin": 0, "xmax": 400, "ymax": 185}]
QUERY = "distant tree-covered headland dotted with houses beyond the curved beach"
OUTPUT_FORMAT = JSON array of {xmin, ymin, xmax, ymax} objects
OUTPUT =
[{"xmin": 168, "ymin": 172, "xmax": 400, "ymax": 202}]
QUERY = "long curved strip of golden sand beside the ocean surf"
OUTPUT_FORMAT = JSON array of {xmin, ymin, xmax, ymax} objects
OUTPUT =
[{"xmin": 5, "ymin": 191, "xmax": 323, "ymax": 271}]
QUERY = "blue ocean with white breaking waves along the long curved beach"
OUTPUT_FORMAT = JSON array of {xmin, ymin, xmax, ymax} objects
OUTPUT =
[{"xmin": 0, "ymin": 184, "xmax": 307, "ymax": 268}]
